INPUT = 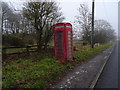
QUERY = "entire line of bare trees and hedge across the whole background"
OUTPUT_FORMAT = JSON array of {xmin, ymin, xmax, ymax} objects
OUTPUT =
[{"xmin": 1, "ymin": 2, "xmax": 116, "ymax": 50}]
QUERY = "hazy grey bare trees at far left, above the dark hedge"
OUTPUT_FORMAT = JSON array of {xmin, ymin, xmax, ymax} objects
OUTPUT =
[{"xmin": 1, "ymin": 2, "xmax": 21, "ymax": 34}]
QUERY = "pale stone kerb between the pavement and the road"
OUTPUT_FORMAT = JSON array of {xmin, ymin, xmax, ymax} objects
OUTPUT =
[{"xmin": 89, "ymin": 44, "xmax": 115, "ymax": 89}]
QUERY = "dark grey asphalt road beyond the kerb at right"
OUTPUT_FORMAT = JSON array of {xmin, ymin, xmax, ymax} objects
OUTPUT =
[{"xmin": 95, "ymin": 42, "xmax": 120, "ymax": 88}]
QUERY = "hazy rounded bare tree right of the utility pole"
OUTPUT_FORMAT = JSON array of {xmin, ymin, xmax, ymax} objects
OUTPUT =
[{"xmin": 94, "ymin": 20, "xmax": 115, "ymax": 43}]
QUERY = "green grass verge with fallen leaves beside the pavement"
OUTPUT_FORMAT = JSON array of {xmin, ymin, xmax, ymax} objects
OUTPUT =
[{"xmin": 2, "ymin": 43, "xmax": 112, "ymax": 88}]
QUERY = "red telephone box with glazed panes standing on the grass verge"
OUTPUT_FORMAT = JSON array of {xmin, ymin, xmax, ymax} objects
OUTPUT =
[{"xmin": 54, "ymin": 23, "xmax": 73, "ymax": 62}]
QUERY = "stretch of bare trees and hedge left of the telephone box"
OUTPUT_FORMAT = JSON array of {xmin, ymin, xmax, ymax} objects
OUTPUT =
[{"xmin": 1, "ymin": 2, "xmax": 64, "ymax": 50}]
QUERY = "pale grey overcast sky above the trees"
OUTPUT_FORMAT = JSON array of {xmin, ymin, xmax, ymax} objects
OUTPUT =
[{"xmin": 2, "ymin": 0, "xmax": 119, "ymax": 32}]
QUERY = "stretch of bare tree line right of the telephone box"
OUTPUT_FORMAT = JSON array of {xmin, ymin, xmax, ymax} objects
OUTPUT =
[{"xmin": 74, "ymin": 4, "xmax": 116, "ymax": 44}]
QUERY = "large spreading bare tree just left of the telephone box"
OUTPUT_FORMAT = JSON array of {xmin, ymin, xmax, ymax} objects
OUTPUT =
[{"xmin": 23, "ymin": 2, "xmax": 63, "ymax": 50}]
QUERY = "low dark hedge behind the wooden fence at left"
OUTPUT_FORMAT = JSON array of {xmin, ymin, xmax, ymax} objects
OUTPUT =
[{"xmin": 2, "ymin": 33, "xmax": 36, "ymax": 46}]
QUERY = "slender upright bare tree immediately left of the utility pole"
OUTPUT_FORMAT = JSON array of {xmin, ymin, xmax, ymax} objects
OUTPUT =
[{"xmin": 75, "ymin": 4, "xmax": 92, "ymax": 43}]
